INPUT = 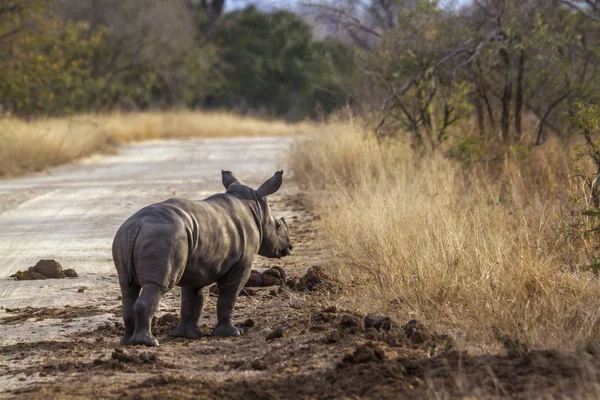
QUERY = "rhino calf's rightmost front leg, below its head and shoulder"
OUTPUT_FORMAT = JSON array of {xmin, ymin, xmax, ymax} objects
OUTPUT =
[{"xmin": 213, "ymin": 263, "xmax": 252, "ymax": 337}]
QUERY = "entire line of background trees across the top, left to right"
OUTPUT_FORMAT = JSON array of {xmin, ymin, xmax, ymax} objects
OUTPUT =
[{"xmin": 0, "ymin": 0, "xmax": 600, "ymax": 142}]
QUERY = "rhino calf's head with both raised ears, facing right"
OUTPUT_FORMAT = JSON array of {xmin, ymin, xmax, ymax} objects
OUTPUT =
[{"xmin": 221, "ymin": 171, "xmax": 292, "ymax": 258}]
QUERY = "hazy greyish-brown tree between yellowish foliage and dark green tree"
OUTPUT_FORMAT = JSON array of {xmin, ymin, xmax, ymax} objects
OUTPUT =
[{"xmin": 59, "ymin": 0, "xmax": 206, "ymax": 109}]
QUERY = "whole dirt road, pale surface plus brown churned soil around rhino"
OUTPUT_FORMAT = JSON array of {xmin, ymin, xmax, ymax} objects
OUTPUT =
[{"xmin": 0, "ymin": 138, "xmax": 600, "ymax": 400}]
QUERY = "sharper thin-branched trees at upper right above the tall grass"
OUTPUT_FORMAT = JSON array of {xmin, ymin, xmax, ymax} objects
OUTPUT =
[{"xmin": 307, "ymin": 0, "xmax": 600, "ymax": 148}]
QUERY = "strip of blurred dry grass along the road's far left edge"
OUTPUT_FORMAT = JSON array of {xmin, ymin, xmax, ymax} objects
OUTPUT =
[{"xmin": 0, "ymin": 111, "xmax": 308, "ymax": 177}]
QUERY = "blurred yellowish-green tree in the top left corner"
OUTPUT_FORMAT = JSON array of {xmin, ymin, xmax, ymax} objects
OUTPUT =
[{"xmin": 0, "ymin": 1, "xmax": 106, "ymax": 116}]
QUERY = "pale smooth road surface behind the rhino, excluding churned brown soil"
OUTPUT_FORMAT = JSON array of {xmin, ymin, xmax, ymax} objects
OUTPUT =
[{"xmin": 0, "ymin": 138, "xmax": 289, "ymax": 307}]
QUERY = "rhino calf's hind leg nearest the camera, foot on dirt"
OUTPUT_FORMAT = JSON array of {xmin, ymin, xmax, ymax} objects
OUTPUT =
[{"xmin": 129, "ymin": 283, "xmax": 164, "ymax": 346}]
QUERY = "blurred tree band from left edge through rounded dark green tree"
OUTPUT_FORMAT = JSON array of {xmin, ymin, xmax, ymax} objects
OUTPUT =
[{"xmin": 0, "ymin": 0, "xmax": 353, "ymax": 119}]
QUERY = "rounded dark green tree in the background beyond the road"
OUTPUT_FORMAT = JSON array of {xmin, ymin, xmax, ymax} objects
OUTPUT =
[{"xmin": 209, "ymin": 6, "xmax": 352, "ymax": 118}]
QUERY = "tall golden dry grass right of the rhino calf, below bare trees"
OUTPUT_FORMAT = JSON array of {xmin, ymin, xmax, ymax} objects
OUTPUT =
[{"xmin": 290, "ymin": 124, "xmax": 600, "ymax": 348}]
